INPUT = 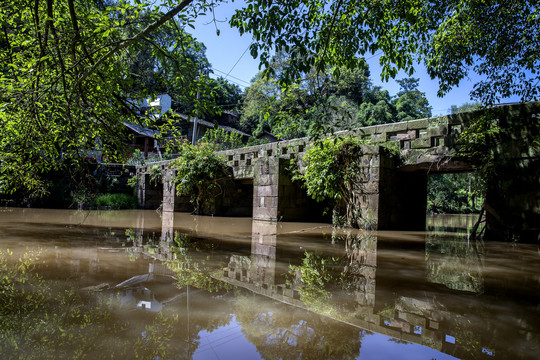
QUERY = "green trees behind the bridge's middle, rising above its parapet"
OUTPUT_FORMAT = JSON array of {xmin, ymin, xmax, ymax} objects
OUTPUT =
[{"xmin": 242, "ymin": 58, "xmax": 431, "ymax": 138}]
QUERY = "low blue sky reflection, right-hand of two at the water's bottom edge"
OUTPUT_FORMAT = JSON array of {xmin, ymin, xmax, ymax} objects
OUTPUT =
[{"xmin": 357, "ymin": 333, "xmax": 457, "ymax": 360}]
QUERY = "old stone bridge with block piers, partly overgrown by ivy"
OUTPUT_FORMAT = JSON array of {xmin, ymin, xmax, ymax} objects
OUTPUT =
[{"xmin": 137, "ymin": 102, "xmax": 540, "ymax": 237}]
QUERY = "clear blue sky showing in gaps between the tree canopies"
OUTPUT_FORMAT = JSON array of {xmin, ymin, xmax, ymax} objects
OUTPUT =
[{"xmin": 187, "ymin": 0, "xmax": 518, "ymax": 116}]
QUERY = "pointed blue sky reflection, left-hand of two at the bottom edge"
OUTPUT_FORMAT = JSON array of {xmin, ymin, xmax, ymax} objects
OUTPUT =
[{"xmin": 193, "ymin": 315, "xmax": 262, "ymax": 360}]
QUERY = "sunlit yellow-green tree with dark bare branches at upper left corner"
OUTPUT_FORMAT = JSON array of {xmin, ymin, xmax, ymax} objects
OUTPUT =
[{"xmin": 0, "ymin": 0, "xmax": 216, "ymax": 196}]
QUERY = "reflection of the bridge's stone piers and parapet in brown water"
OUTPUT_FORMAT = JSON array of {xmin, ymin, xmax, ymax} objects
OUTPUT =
[{"xmin": 221, "ymin": 221, "xmax": 454, "ymax": 353}]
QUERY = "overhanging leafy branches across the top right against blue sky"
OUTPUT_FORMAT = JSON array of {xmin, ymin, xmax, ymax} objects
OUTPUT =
[{"xmin": 231, "ymin": 0, "xmax": 540, "ymax": 104}]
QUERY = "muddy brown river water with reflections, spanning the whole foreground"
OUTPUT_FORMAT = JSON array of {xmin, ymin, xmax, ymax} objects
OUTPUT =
[{"xmin": 0, "ymin": 208, "xmax": 540, "ymax": 360}]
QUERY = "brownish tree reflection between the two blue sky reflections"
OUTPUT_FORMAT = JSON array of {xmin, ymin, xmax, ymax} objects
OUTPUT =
[{"xmin": 236, "ymin": 296, "xmax": 364, "ymax": 360}]
